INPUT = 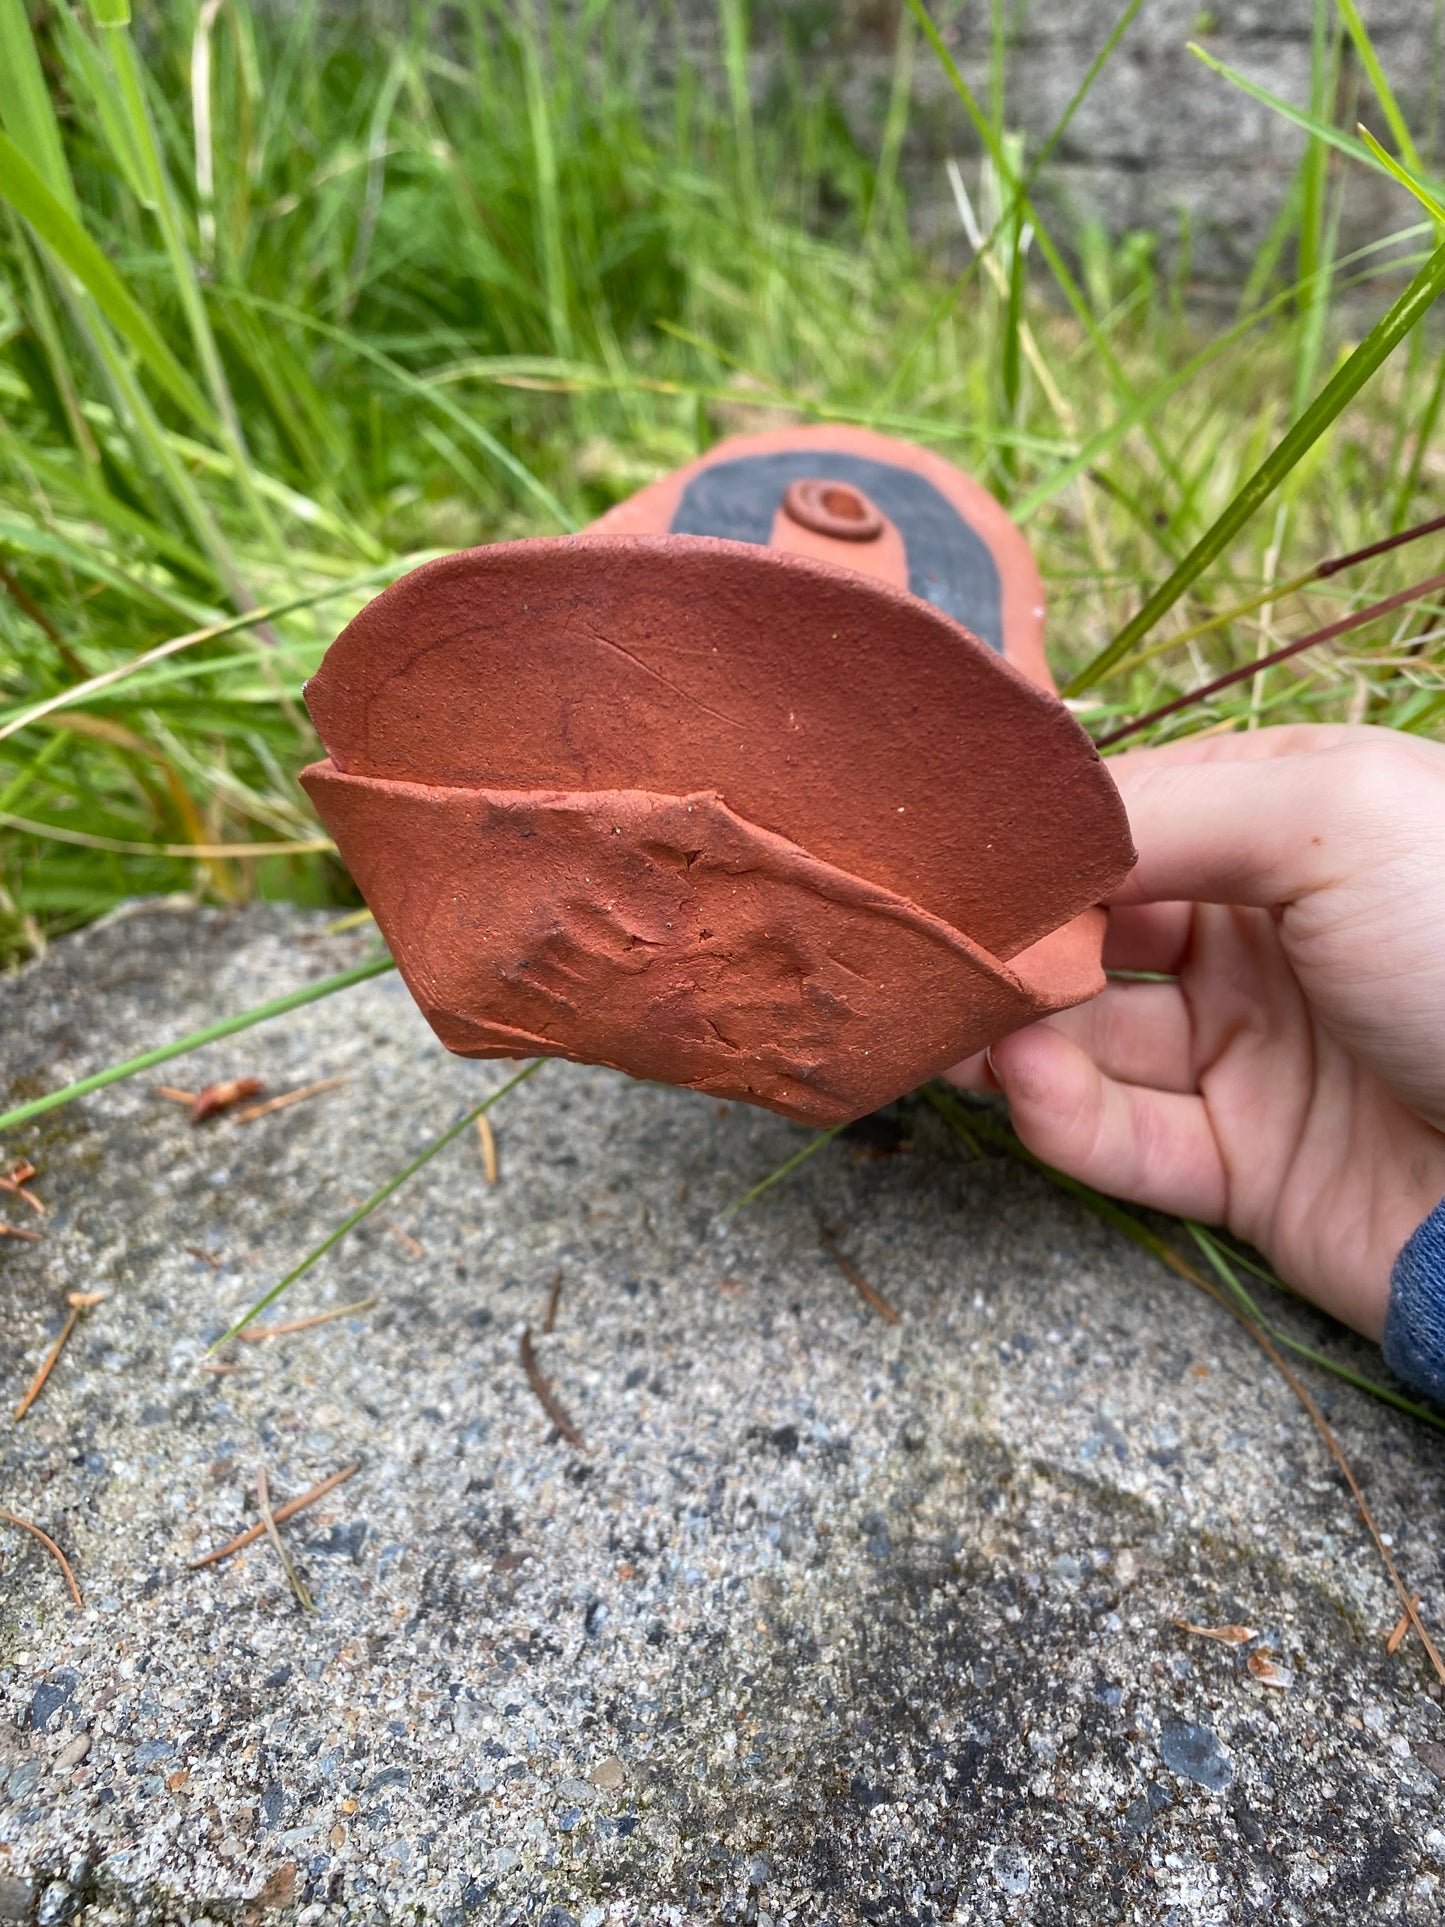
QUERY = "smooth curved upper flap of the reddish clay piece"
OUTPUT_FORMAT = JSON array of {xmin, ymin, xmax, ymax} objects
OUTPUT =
[{"xmin": 306, "ymin": 532, "xmax": 1133, "ymax": 958}]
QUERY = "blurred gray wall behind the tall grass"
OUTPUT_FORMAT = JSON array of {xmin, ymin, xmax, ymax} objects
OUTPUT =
[{"xmin": 709, "ymin": 0, "xmax": 1445, "ymax": 287}]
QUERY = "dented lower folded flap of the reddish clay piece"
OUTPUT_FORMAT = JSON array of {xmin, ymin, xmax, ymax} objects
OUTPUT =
[{"xmin": 301, "ymin": 761, "xmax": 1104, "ymax": 1125}]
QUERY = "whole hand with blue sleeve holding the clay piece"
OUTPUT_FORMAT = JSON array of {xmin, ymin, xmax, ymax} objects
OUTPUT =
[{"xmin": 950, "ymin": 726, "xmax": 1445, "ymax": 1339}]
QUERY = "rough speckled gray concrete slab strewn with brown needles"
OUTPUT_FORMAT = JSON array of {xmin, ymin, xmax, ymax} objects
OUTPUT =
[{"xmin": 0, "ymin": 906, "xmax": 1445, "ymax": 1927}]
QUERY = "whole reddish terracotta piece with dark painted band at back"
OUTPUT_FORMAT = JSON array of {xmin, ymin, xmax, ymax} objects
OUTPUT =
[{"xmin": 302, "ymin": 428, "xmax": 1133, "ymax": 1123}]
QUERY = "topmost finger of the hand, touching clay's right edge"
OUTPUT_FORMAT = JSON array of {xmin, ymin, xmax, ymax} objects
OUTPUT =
[{"xmin": 1110, "ymin": 730, "xmax": 1445, "ymax": 908}]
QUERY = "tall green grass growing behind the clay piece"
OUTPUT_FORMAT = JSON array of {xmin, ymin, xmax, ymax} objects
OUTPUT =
[{"xmin": 0, "ymin": 0, "xmax": 1445, "ymax": 962}]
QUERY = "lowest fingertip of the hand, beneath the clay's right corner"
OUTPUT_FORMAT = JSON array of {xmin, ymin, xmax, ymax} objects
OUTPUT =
[{"xmin": 990, "ymin": 1023, "xmax": 1229, "ymax": 1224}]
